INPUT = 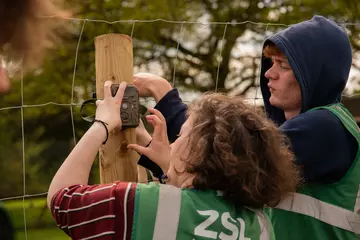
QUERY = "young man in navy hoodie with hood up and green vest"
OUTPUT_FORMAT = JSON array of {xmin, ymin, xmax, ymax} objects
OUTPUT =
[{"xmin": 134, "ymin": 16, "xmax": 360, "ymax": 240}]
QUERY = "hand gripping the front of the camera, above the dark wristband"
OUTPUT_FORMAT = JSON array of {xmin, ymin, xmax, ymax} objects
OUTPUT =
[{"xmin": 95, "ymin": 81, "xmax": 127, "ymax": 132}]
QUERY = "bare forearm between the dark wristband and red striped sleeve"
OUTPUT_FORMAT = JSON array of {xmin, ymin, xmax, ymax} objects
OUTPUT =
[{"xmin": 47, "ymin": 123, "xmax": 106, "ymax": 207}]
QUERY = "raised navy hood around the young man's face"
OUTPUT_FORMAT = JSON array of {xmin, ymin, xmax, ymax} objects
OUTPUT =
[{"xmin": 260, "ymin": 16, "xmax": 352, "ymax": 125}]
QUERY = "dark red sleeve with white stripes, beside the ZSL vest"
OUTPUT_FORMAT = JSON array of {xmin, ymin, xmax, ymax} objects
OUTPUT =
[{"xmin": 51, "ymin": 182, "xmax": 136, "ymax": 240}]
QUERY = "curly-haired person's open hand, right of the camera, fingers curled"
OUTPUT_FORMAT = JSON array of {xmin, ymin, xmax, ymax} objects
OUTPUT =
[{"xmin": 128, "ymin": 109, "xmax": 170, "ymax": 173}]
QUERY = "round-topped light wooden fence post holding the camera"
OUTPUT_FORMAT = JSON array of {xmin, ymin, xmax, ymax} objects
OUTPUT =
[{"xmin": 95, "ymin": 34, "xmax": 139, "ymax": 183}]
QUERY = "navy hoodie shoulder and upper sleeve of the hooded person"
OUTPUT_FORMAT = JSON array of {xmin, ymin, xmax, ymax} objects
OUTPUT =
[{"xmin": 280, "ymin": 109, "xmax": 358, "ymax": 183}]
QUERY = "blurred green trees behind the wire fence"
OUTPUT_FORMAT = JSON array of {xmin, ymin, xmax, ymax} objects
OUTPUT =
[{"xmin": 0, "ymin": 0, "xmax": 360, "ymax": 198}]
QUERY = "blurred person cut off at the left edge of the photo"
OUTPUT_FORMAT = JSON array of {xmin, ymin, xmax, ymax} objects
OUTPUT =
[{"xmin": 0, "ymin": 0, "xmax": 70, "ymax": 240}]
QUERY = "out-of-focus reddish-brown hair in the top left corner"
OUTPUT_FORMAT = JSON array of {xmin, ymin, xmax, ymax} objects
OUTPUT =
[{"xmin": 0, "ymin": 0, "xmax": 70, "ymax": 70}]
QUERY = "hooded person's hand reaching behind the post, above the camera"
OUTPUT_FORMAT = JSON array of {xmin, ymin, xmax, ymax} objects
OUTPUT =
[{"xmin": 134, "ymin": 73, "xmax": 172, "ymax": 102}]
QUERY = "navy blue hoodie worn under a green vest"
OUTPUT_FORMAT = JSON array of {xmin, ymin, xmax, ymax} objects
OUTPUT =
[{"xmin": 143, "ymin": 16, "xmax": 357, "ymax": 183}]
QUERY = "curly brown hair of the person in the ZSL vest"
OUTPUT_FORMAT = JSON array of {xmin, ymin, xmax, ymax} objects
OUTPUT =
[{"xmin": 182, "ymin": 93, "xmax": 300, "ymax": 208}]
